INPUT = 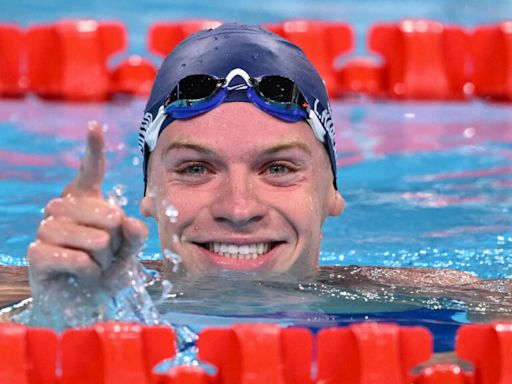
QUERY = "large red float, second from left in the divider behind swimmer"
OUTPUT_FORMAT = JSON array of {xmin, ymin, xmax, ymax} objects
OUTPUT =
[{"xmin": 26, "ymin": 20, "xmax": 126, "ymax": 100}]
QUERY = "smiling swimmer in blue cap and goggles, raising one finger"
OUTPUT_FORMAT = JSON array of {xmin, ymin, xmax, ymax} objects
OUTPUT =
[{"xmin": 1, "ymin": 24, "xmax": 496, "ymax": 320}]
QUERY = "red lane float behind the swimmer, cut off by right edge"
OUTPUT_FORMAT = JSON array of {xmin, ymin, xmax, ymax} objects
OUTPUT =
[{"xmin": 471, "ymin": 21, "xmax": 512, "ymax": 100}]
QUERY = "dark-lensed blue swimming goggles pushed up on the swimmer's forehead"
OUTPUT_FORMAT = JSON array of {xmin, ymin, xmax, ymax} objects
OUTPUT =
[{"xmin": 145, "ymin": 68, "xmax": 326, "ymax": 152}]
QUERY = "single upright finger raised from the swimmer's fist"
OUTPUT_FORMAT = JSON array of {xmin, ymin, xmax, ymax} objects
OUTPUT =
[{"xmin": 63, "ymin": 121, "xmax": 105, "ymax": 196}]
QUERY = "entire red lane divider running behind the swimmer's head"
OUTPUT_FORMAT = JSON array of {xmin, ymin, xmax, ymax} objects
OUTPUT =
[{"xmin": 5, "ymin": 20, "xmax": 512, "ymax": 101}]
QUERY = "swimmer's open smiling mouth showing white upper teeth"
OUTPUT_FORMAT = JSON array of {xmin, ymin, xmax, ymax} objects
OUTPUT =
[{"xmin": 194, "ymin": 241, "xmax": 284, "ymax": 271}]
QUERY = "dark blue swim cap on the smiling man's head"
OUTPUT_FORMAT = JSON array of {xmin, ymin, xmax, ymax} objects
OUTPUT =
[{"xmin": 139, "ymin": 23, "xmax": 337, "ymax": 188}]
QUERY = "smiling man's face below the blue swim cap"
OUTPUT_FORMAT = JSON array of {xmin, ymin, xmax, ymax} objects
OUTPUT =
[{"xmin": 141, "ymin": 102, "xmax": 344, "ymax": 276}]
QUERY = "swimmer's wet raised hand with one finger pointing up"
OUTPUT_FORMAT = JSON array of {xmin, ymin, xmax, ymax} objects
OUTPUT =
[{"xmin": 27, "ymin": 122, "xmax": 147, "ymax": 308}]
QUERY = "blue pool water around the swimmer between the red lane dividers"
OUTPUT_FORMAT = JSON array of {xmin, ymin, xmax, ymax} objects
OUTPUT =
[{"xmin": 0, "ymin": 96, "xmax": 512, "ymax": 350}]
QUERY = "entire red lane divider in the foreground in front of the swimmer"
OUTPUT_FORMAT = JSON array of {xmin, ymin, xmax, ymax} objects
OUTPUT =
[{"xmin": 0, "ymin": 322, "xmax": 512, "ymax": 384}]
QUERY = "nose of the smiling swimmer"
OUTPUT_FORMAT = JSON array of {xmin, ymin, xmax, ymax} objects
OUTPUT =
[{"xmin": 210, "ymin": 170, "xmax": 268, "ymax": 229}]
